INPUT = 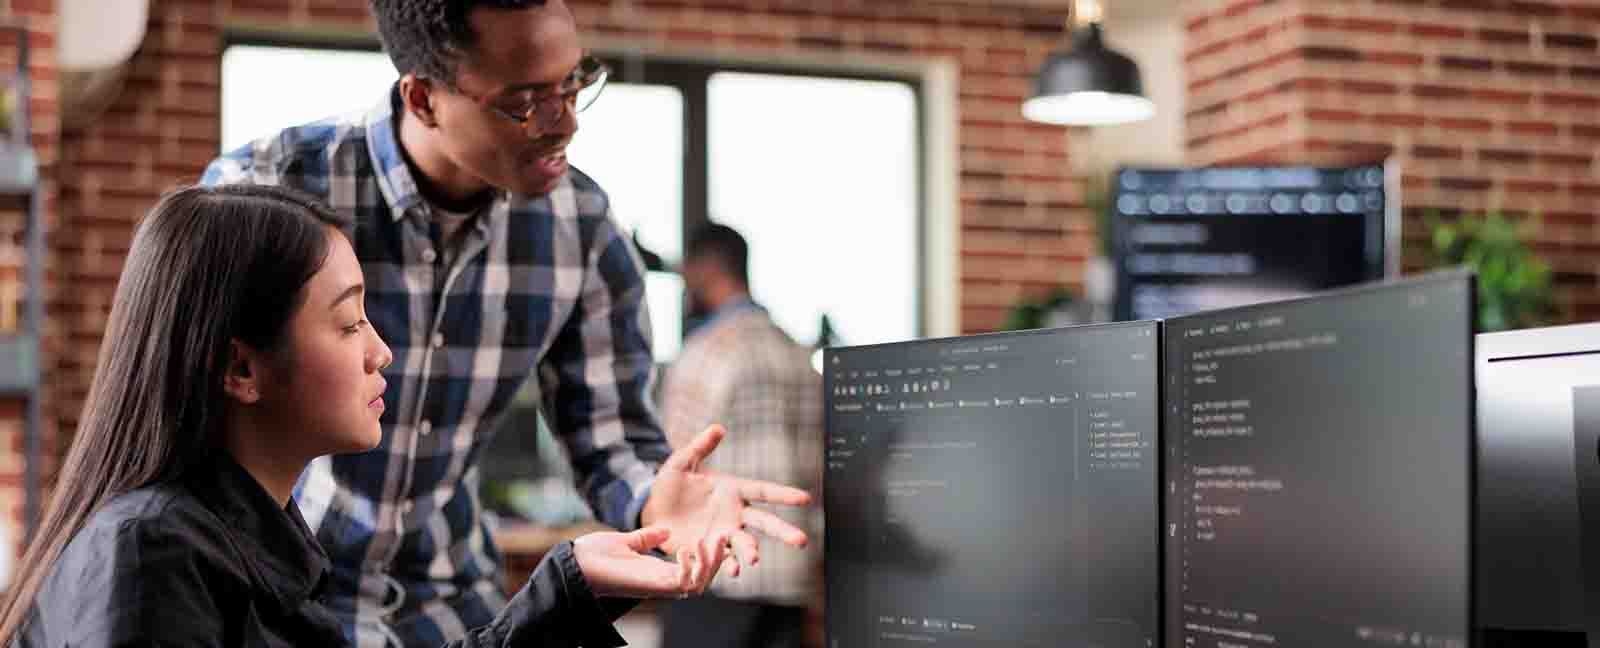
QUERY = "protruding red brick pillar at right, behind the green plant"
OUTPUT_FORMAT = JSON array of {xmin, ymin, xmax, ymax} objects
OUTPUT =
[{"xmin": 1184, "ymin": 0, "xmax": 1600, "ymax": 320}]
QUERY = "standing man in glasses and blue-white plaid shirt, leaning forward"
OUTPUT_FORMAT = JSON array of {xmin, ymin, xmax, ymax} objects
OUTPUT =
[{"xmin": 203, "ymin": 0, "xmax": 810, "ymax": 648}]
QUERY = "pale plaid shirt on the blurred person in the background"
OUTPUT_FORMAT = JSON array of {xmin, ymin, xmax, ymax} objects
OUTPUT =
[{"xmin": 661, "ymin": 301, "xmax": 822, "ymax": 606}]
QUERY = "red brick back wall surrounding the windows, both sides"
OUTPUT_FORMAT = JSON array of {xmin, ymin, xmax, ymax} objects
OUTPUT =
[{"xmin": 0, "ymin": 0, "xmax": 1094, "ymax": 544}]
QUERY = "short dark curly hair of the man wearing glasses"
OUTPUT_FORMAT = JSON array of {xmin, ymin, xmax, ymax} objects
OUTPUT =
[{"xmin": 371, "ymin": 0, "xmax": 546, "ymax": 83}]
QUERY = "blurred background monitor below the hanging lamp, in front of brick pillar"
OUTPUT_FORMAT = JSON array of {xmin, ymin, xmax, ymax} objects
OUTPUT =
[{"xmin": 1109, "ymin": 163, "xmax": 1400, "ymax": 320}]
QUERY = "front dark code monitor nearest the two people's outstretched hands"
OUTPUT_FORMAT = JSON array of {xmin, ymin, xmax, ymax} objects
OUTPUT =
[{"xmin": 822, "ymin": 323, "xmax": 1160, "ymax": 648}]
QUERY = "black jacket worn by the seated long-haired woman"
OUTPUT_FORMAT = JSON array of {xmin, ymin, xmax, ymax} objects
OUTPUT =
[{"xmin": 18, "ymin": 454, "xmax": 629, "ymax": 648}]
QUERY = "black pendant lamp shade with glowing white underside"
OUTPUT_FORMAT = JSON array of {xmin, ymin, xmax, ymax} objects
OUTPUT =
[{"xmin": 1022, "ymin": 22, "xmax": 1155, "ymax": 126}]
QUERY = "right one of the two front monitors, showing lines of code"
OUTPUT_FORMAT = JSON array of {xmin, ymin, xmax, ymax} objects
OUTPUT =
[{"xmin": 1162, "ymin": 275, "xmax": 1474, "ymax": 648}]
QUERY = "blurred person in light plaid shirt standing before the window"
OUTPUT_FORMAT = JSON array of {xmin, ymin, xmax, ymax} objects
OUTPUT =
[{"xmin": 661, "ymin": 224, "xmax": 822, "ymax": 648}]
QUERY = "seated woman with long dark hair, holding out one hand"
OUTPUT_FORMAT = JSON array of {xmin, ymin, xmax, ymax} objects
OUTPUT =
[{"xmin": 0, "ymin": 186, "xmax": 726, "ymax": 648}]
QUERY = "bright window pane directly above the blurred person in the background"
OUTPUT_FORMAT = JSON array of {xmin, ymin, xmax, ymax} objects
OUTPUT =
[{"xmin": 707, "ymin": 72, "xmax": 920, "ymax": 344}]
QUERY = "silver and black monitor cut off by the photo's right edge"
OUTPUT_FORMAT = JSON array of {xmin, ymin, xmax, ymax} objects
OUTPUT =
[{"xmin": 1477, "ymin": 325, "xmax": 1600, "ymax": 648}]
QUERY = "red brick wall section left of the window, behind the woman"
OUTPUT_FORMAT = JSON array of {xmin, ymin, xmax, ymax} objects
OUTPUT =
[{"xmin": 51, "ymin": 0, "xmax": 366, "ymax": 430}]
